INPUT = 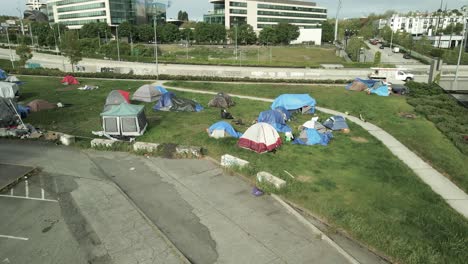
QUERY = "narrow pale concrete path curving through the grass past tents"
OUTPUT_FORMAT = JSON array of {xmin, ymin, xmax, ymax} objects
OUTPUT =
[{"xmin": 160, "ymin": 81, "xmax": 468, "ymax": 218}]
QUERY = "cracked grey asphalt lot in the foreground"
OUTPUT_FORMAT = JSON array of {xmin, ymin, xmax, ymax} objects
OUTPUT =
[{"xmin": 0, "ymin": 141, "xmax": 381, "ymax": 264}]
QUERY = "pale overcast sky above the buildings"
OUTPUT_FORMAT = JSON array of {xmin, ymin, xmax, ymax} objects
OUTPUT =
[{"xmin": 0, "ymin": 0, "xmax": 468, "ymax": 20}]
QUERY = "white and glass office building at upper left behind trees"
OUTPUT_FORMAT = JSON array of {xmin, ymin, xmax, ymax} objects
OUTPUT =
[{"xmin": 47, "ymin": 0, "xmax": 166, "ymax": 29}]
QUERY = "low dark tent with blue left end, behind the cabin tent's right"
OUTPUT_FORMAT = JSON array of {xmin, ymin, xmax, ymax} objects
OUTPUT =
[{"xmin": 153, "ymin": 92, "xmax": 203, "ymax": 112}]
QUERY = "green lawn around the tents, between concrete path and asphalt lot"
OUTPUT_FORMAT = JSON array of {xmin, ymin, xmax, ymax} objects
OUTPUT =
[{"xmin": 17, "ymin": 77, "xmax": 468, "ymax": 263}]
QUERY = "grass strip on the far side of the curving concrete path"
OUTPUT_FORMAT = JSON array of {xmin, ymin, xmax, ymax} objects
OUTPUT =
[{"xmin": 168, "ymin": 81, "xmax": 468, "ymax": 192}]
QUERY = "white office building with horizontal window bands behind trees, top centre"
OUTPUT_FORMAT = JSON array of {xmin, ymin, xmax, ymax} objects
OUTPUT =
[{"xmin": 203, "ymin": 0, "xmax": 327, "ymax": 45}]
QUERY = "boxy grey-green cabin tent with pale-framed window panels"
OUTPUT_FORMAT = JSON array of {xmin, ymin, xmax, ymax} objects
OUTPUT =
[{"xmin": 101, "ymin": 103, "xmax": 148, "ymax": 136}]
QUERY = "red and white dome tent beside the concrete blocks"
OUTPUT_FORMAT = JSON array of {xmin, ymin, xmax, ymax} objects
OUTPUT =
[{"xmin": 237, "ymin": 123, "xmax": 282, "ymax": 153}]
